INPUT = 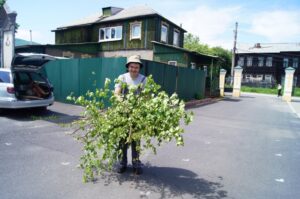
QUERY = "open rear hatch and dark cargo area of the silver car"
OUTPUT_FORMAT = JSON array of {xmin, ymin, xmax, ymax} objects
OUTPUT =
[{"xmin": 11, "ymin": 53, "xmax": 57, "ymax": 100}]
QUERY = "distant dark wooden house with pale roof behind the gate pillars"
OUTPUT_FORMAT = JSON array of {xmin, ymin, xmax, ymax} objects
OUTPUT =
[{"xmin": 235, "ymin": 43, "xmax": 300, "ymax": 86}]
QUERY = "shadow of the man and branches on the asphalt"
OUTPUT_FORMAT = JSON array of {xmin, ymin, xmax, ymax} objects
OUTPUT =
[{"xmin": 101, "ymin": 166, "xmax": 227, "ymax": 199}]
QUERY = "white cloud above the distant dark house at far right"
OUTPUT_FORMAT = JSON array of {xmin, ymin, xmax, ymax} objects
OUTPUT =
[{"xmin": 249, "ymin": 10, "xmax": 300, "ymax": 42}]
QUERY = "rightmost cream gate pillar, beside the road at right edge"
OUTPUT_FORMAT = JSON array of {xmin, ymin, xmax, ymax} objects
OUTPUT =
[{"xmin": 282, "ymin": 67, "xmax": 295, "ymax": 102}]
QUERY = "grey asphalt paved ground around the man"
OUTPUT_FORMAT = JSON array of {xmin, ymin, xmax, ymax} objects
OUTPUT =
[{"xmin": 0, "ymin": 94, "xmax": 300, "ymax": 199}]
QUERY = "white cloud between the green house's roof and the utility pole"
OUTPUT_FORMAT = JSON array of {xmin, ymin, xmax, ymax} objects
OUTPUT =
[{"xmin": 173, "ymin": 6, "xmax": 241, "ymax": 49}]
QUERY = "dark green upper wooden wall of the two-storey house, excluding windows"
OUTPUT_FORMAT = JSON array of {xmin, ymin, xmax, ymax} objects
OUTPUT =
[{"xmin": 55, "ymin": 16, "xmax": 184, "ymax": 51}]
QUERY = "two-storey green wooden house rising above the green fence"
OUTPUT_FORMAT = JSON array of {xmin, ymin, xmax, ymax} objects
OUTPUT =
[{"xmin": 16, "ymin": 6, "xmax": 217, "ymax": 68}]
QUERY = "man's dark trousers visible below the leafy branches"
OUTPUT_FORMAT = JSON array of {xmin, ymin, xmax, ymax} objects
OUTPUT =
[{"xmin": 119, "ymin": 141, "xmax": 141, "ymax": 168}]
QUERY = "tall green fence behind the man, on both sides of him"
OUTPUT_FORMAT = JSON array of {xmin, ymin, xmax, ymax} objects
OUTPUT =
[{"xmin": 45, "ymin": 57, "xmax": 205, "ymax": 102}]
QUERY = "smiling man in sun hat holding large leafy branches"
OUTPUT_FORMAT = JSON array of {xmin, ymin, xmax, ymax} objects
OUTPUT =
[{"xmin": 115, "ymin": 55, "xmax": 146, "ymax": 175}]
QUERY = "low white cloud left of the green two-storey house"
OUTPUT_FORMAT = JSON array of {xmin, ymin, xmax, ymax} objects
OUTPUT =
[{"xmin": 16, "ymin": 29, "xmax": 54, "ymax": 44}]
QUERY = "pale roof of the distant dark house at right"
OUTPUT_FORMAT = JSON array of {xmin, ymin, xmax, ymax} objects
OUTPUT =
[{"xmin": 236, "ymin": 43, "xmax": 300, "ymax": 54}]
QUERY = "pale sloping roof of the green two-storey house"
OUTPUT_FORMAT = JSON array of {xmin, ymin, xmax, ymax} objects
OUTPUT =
[{"xmin": 54, "ymin": 5, "xmax": 185, "ymax": 31}]
